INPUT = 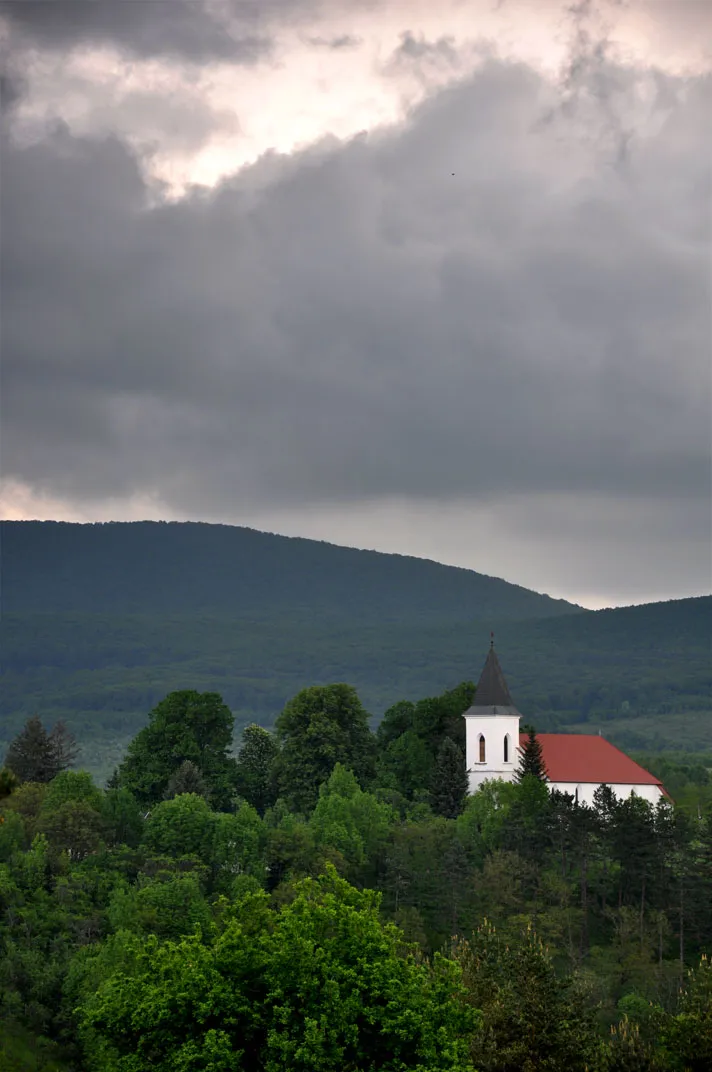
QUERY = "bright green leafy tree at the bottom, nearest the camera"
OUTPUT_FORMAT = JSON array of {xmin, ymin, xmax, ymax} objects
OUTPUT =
[{"xmin": 80, "ymin": 869, "xmax": 476, "ymax": 1072}]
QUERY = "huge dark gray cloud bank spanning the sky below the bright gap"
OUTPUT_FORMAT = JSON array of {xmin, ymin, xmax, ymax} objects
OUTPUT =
[{"xmin": 0, "ymin": 54, "xmax": 712, "ymax": 536}]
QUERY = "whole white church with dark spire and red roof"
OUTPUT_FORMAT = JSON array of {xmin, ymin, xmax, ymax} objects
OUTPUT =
[{"xmin": 464, "ymin": 638, "xmax": 668, "ymax": 804}]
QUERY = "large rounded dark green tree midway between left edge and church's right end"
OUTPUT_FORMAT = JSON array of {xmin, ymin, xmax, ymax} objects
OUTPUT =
[{"xmin": 276, "ymin": 685, "xmax": 375, "ymax": 813}]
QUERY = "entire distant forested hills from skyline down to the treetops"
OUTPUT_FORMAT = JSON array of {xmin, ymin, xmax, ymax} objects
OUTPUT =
[{"xmin": 0, "ymin": 522, "xmax": 712, "ymax": 774}]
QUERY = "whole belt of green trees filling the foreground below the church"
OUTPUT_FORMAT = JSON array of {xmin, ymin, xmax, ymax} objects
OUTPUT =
[{"xmin": 0, "ymin": 683, "xmax": 712, "ymax": 1072}]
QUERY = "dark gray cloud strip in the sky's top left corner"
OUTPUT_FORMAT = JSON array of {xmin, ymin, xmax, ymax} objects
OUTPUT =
[{"xmin": 0, "ymin": 0, "xmax": 270, "ymax": 62}]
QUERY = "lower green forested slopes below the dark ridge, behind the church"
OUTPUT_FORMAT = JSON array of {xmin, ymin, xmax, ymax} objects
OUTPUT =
[{"xmin": 0, "ymin": 599, "xmax": 712, "ymax": 777}]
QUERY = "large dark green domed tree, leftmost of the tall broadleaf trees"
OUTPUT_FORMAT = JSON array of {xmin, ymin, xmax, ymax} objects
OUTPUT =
[{"xmin": 118, "ymin": 690, "xmax": 235, "ymax": 809}]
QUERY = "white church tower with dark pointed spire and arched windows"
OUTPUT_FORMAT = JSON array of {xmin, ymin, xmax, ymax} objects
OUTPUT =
[{"xmin": 464, "ymin": 635, "xmax": 521, "ymax": 793}]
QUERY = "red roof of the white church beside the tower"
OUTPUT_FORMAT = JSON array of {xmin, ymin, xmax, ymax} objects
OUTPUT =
[{"xmin": 519, "ymin": 733, "xmax": 663, "ymax": 789}]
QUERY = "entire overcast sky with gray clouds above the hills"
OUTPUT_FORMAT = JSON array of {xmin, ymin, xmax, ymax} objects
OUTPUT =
[{"xmin": 0, "ymin": 0, "xmax": 712, "ymax": 607}]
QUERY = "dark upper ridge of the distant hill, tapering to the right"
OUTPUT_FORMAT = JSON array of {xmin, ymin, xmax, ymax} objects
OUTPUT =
[{"xmin": 0, "ymin": 521, "xmax": 580, "ymax": 622}]
